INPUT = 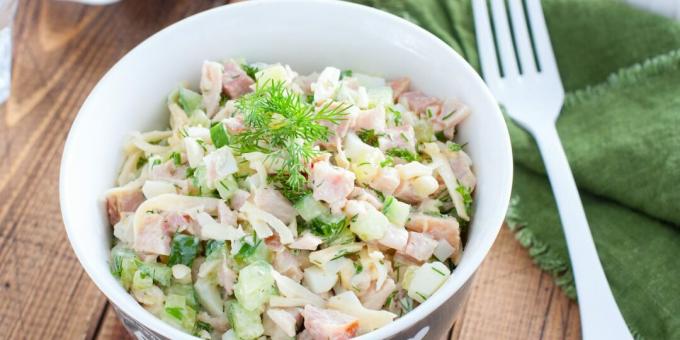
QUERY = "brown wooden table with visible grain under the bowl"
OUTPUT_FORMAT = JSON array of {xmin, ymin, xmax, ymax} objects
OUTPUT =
[{"xmin": 0, "ymin": 0, "xmax": 579, "ymax": 339}]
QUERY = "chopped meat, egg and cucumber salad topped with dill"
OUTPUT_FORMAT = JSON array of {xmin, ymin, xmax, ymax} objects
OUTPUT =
[{"xmin": 106, "ymin": 60, "xmax": 476, "ymax": 340}]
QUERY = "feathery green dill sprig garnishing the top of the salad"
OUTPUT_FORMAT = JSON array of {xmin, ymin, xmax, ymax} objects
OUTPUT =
[{"xmin": 231, "ymin": 81, "xmax": 349, "ymax": 190}]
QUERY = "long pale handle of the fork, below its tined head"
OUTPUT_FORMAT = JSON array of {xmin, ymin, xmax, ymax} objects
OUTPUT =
[{"xmin": 533, "ymin": 124, "xmax": 632, "ymax": 340}]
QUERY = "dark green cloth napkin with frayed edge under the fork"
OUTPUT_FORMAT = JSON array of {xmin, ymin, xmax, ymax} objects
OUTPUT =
[{"xmin": 354, "ymin": 0, "xmax": 680, "ymax": 339}]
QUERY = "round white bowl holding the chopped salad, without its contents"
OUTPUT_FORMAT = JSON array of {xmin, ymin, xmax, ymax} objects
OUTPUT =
[{"xmin": 60, "ymin": 0, "xmax": 512, "ymax": 339}]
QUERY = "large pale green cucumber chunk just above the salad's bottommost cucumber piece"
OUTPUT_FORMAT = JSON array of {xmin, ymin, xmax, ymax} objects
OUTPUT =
[{"xmin": 234, "ymin": 261, "xmax": 274, "ymax": 311}]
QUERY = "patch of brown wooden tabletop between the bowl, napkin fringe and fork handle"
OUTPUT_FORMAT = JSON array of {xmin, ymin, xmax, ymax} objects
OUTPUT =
[{"xmin": 451, "ymin": 226, "xmax": 581, "ymax": 340}]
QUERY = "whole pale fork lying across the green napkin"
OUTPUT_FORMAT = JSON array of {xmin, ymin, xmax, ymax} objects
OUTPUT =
[{"xmin": 472, "ymin": 0, "xmax": 632, "ymax": 340}]
